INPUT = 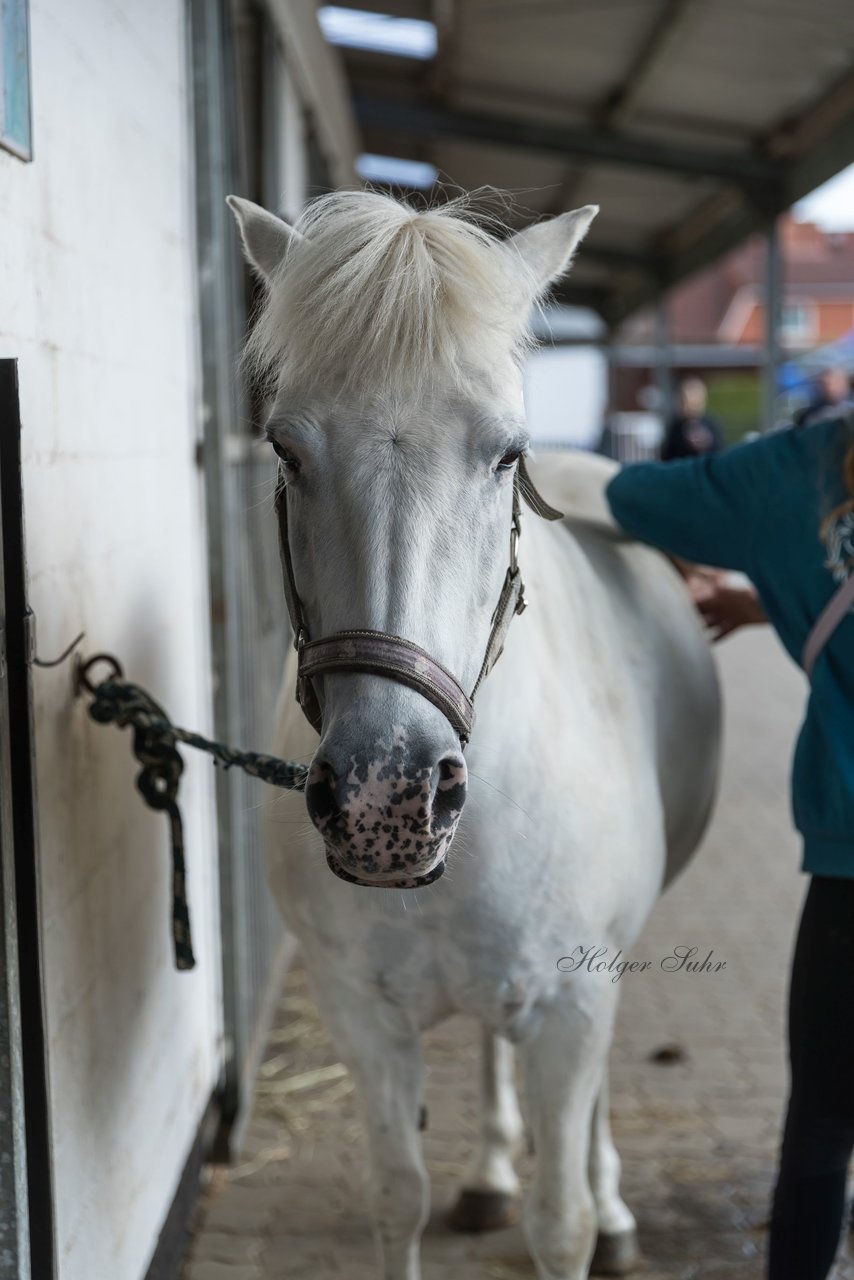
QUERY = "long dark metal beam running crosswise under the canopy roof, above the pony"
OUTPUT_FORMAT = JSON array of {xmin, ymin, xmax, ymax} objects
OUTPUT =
[{"xmin": 353, "ymin": 93, "xmax": 784, "ymax": 189}]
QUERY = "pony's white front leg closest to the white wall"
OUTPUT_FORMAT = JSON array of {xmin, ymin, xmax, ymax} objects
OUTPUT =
[{"xmin": 312, "ymin": 974, "xmax": 430, "ymax": 1280}]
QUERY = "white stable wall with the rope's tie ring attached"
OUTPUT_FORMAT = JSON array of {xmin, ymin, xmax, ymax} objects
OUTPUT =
[{"xmin": 0, "ymin": 0, "xmax": 220, "ymax": 1280}]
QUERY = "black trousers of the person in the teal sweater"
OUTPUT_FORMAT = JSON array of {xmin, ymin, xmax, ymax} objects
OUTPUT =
[{"xmin": 768, "ymin": 876, "xmax": 854, "ymax": 1280}]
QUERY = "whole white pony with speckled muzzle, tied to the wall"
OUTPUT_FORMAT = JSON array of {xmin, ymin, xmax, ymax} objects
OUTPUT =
[{"xmin": 229, "ymin": 192, "xmax": 720, "ymax": 1280}]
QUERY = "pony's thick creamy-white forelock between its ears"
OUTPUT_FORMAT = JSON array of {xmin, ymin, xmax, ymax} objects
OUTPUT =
[{"xmin": 246, "ymin": 191, "xmax": 538, "ymax": 389}]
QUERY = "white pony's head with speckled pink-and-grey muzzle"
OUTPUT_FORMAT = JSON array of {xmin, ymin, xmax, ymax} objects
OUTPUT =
[{"xmin": 229, "ymin": 192, "xmax": 597, "ymax": 887}]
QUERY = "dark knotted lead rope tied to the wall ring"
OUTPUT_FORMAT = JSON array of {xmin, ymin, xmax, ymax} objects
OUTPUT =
[{"xmin": 76, "ymin": 653, "xmax": 307, "ymax": 970}]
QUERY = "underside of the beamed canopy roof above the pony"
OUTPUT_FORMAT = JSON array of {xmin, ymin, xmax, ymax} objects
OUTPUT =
[{"xmin": 335, "ymin": 0, "xmax": 854, "ymax": 323}]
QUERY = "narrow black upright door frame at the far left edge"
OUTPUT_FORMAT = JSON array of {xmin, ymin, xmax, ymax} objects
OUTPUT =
[{"xmin": 0, "ymin": 360, "xmax": 55, "ymax": 1280}]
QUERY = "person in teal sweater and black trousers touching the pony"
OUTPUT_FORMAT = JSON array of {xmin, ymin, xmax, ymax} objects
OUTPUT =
[{"xmin": 607, "ymin": 415, "xmax": 854, "ymax": 1280}]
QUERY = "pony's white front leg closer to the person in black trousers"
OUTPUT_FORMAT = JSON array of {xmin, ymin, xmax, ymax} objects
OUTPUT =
[{"xmin": 521, "ymin": 988, "xmax": 616, "ymax": 1280}]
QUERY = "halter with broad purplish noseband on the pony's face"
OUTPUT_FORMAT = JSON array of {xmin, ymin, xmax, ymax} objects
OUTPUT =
[{"xmin": 275, "ymin": 457, "xmax": 563, "ymax": 746}]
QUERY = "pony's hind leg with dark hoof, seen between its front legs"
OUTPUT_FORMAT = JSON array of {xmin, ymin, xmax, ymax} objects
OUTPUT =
[{"xmin": 449, "ymin": 1027, "xmax": 524, "ymax": 1231}]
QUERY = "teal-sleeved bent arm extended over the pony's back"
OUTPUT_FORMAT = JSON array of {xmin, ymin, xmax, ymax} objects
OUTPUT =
[{"xmin": 606, "ymin": 440, "xmax": 773, "ymax": 570}]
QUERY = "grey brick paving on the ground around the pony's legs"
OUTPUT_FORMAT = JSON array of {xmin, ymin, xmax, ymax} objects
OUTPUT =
[{"xmin": 182, "ymin": 631, "xmax": 854, "ymax": 1280}]
